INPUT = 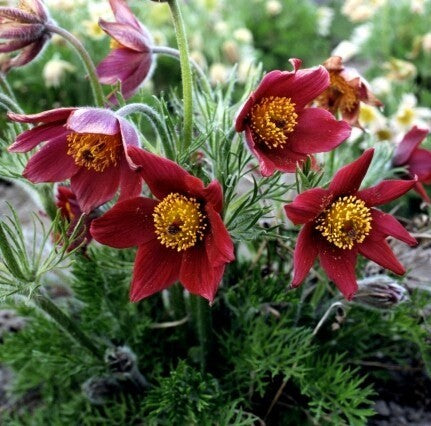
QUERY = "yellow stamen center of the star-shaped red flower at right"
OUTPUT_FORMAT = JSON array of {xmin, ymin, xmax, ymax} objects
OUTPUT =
[{"xmin": 316, "ymin": 195, "xmax": 372, "ymax": 250}]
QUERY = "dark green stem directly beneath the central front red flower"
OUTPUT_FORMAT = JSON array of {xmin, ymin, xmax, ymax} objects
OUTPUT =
[{"xmin": 190, "ymin": 294, "xmax": 211, "ymax": 371}]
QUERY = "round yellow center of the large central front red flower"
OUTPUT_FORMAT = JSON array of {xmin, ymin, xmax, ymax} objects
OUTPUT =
[{"xmin": 153, "ymin": 193, "xmax": 207, "ymax": 251}]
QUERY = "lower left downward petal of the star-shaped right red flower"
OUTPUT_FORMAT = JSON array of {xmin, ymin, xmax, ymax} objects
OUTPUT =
[{"xmin": 292, "ymin": 223, "xmax": 318, "ymax": 287}]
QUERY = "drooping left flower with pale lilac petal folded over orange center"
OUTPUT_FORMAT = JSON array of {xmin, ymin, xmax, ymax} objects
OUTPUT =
[{"xmin": 8, "ymin": 108, "xmax": 142, "ymax": 213}]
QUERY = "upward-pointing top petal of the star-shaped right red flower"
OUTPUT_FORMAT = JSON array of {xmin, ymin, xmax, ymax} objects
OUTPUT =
[{"xmin": 329, "ymin": 149, "xmax": 374, "ymax": 198}]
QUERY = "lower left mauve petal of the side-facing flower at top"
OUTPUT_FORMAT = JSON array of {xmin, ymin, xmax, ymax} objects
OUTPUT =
[{"xmin": 97, "ymin": 48, "xmax": 142, "ymax": 84}]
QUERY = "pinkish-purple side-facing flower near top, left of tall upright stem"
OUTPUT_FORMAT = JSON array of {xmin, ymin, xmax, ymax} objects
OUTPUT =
[{"xmin": 97, "ymin": 0, "xmax": 154, "ymax": 102}]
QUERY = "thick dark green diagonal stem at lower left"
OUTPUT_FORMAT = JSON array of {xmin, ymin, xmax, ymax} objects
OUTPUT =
[{"xmin": 34, "ymin": 294, "xmax": 103, "ymax": 360}]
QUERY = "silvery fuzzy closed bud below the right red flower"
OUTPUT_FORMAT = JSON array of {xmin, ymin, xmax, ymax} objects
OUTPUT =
[{"xmin": 353, "ymin": 275, "xmax": 408, "ymax": 309}]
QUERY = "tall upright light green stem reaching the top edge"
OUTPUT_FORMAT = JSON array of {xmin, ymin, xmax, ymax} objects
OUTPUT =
[{"xmin": 168, "ymin": 0, "xmax": 193, "ymax": 151}]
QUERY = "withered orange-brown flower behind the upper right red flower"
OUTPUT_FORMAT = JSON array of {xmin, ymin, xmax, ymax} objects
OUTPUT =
[{"xmin": 317, "ymin": 56, "xmax": 383, "ymax": 127}]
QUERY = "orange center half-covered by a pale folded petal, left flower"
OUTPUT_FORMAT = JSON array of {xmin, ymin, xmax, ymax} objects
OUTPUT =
[{"xmin": 67, "ymin": 133, "xmax": 122, "ymax": 172}]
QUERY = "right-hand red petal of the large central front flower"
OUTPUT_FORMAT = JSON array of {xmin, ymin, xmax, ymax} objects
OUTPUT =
[{"xmin": 205, "ymin": 205, "xmax": 235, "ymax": 267}]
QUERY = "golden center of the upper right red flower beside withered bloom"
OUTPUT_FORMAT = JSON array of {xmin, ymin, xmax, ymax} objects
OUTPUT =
[{"xmin": 250, "ymin": 96, "xmax": 298, "ymax": 149}]
